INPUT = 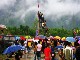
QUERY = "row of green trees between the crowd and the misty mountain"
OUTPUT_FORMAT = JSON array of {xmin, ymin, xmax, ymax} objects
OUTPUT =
[{"xmin": 0, "ymin": 25, "xmax": 80, "ymax": 37}]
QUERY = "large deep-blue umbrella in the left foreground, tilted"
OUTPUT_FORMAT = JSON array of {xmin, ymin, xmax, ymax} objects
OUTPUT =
[{"xmin": 3, "ymin": 45, "xmax": 24, "ymax": 54}]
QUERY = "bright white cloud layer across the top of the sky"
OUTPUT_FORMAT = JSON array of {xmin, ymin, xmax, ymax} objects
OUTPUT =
[{"xmin": 0, "ymin": 0, "xmax": 80, "ymax": 19}]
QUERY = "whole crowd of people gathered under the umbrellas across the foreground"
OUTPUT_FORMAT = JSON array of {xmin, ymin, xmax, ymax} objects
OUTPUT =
[{"xmin": 4, "ymin": 36, "xmax": 80, "ymax": 60}]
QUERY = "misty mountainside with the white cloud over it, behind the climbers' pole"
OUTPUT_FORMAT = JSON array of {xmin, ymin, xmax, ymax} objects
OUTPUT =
[{"xmin": 0, "ymin": 0, "xmax": 80, "ymax": 29}]
